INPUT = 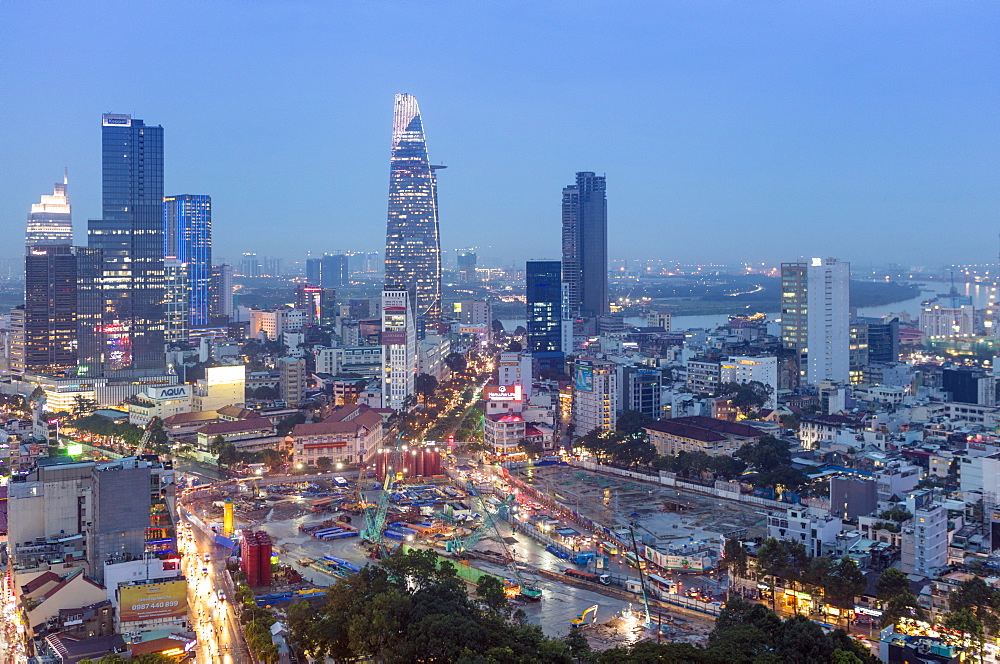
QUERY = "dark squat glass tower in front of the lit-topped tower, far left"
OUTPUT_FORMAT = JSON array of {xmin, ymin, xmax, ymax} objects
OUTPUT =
[{"xmin": 10, "ymin": 245, "xmax": 77, "ymax": 374}]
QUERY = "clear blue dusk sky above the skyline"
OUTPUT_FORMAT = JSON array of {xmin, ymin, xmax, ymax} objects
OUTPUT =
[{"xmin": 0, "ymin": 0, "xmax": 1000, "ymax": 265}]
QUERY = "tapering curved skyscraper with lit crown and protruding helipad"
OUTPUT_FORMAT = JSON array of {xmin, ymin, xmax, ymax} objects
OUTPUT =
[{"xmin": 385, "ymin": 94, "xmax": 442, "ymax": 326}]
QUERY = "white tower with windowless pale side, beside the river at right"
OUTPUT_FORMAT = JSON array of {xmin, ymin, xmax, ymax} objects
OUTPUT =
[{"xmin": 781, "ymin": 258, "xmax": 851, "ymax": 385}]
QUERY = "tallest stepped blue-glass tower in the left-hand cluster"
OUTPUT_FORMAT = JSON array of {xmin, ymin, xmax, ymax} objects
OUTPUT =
[{"xmin": 78, "ymin": 114, "xmax": 166, "ymax": 378}]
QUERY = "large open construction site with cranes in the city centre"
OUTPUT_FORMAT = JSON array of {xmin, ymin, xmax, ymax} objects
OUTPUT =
[{"xmin": 180, "ymin": 460, "xmax": 766, "ymax": 648}]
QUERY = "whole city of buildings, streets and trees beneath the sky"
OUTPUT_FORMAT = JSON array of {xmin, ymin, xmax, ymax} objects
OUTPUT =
[{"xmin": 0, "ymin": 94, "xmax": 1000, "ymax": 664}]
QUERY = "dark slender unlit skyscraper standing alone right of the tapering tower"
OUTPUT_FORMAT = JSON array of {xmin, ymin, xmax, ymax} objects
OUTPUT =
[{"xmin": 562, "ymin": 172, "xmax": 609, "ymax": 318}]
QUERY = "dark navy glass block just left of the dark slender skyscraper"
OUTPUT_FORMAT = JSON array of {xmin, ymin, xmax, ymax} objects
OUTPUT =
[{"xmin": 524, "ymin": 260, "xmax": 564, "ymax": 371}]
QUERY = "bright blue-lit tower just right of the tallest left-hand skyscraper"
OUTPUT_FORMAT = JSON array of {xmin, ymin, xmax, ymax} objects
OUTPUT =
[{"xmin": 163, "ymin": 194, "xmax": 212, "ymax": 327}]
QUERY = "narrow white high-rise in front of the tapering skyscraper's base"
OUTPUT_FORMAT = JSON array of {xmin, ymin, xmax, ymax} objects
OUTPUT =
[{"xmin": 382, "ymin": 286, "xmax": 417, "ymax": 410}]
